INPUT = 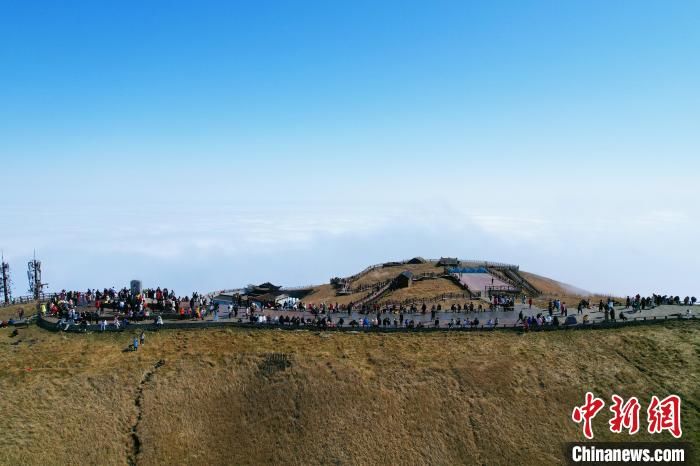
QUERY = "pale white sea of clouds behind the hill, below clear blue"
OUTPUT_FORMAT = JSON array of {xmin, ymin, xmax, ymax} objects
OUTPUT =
[{"xmin": 3, "ymin": 177, "xmax": 700, "ymax": 294}]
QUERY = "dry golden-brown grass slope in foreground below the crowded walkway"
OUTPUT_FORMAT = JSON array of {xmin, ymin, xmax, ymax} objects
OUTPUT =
[{"xmin": 0, "ymin": 322, "xmax": 700, "ymax": 465}]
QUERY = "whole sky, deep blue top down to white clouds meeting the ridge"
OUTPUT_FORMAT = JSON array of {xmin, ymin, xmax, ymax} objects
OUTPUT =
[{"xmin": 0, "ymin": 1, "xmax": 700, "ymax": 295}]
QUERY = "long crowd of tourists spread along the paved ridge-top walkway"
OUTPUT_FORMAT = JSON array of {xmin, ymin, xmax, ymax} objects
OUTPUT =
[{"xmin": 6, "ymin": 278, "xmax": 697, "ymax": 331}]
